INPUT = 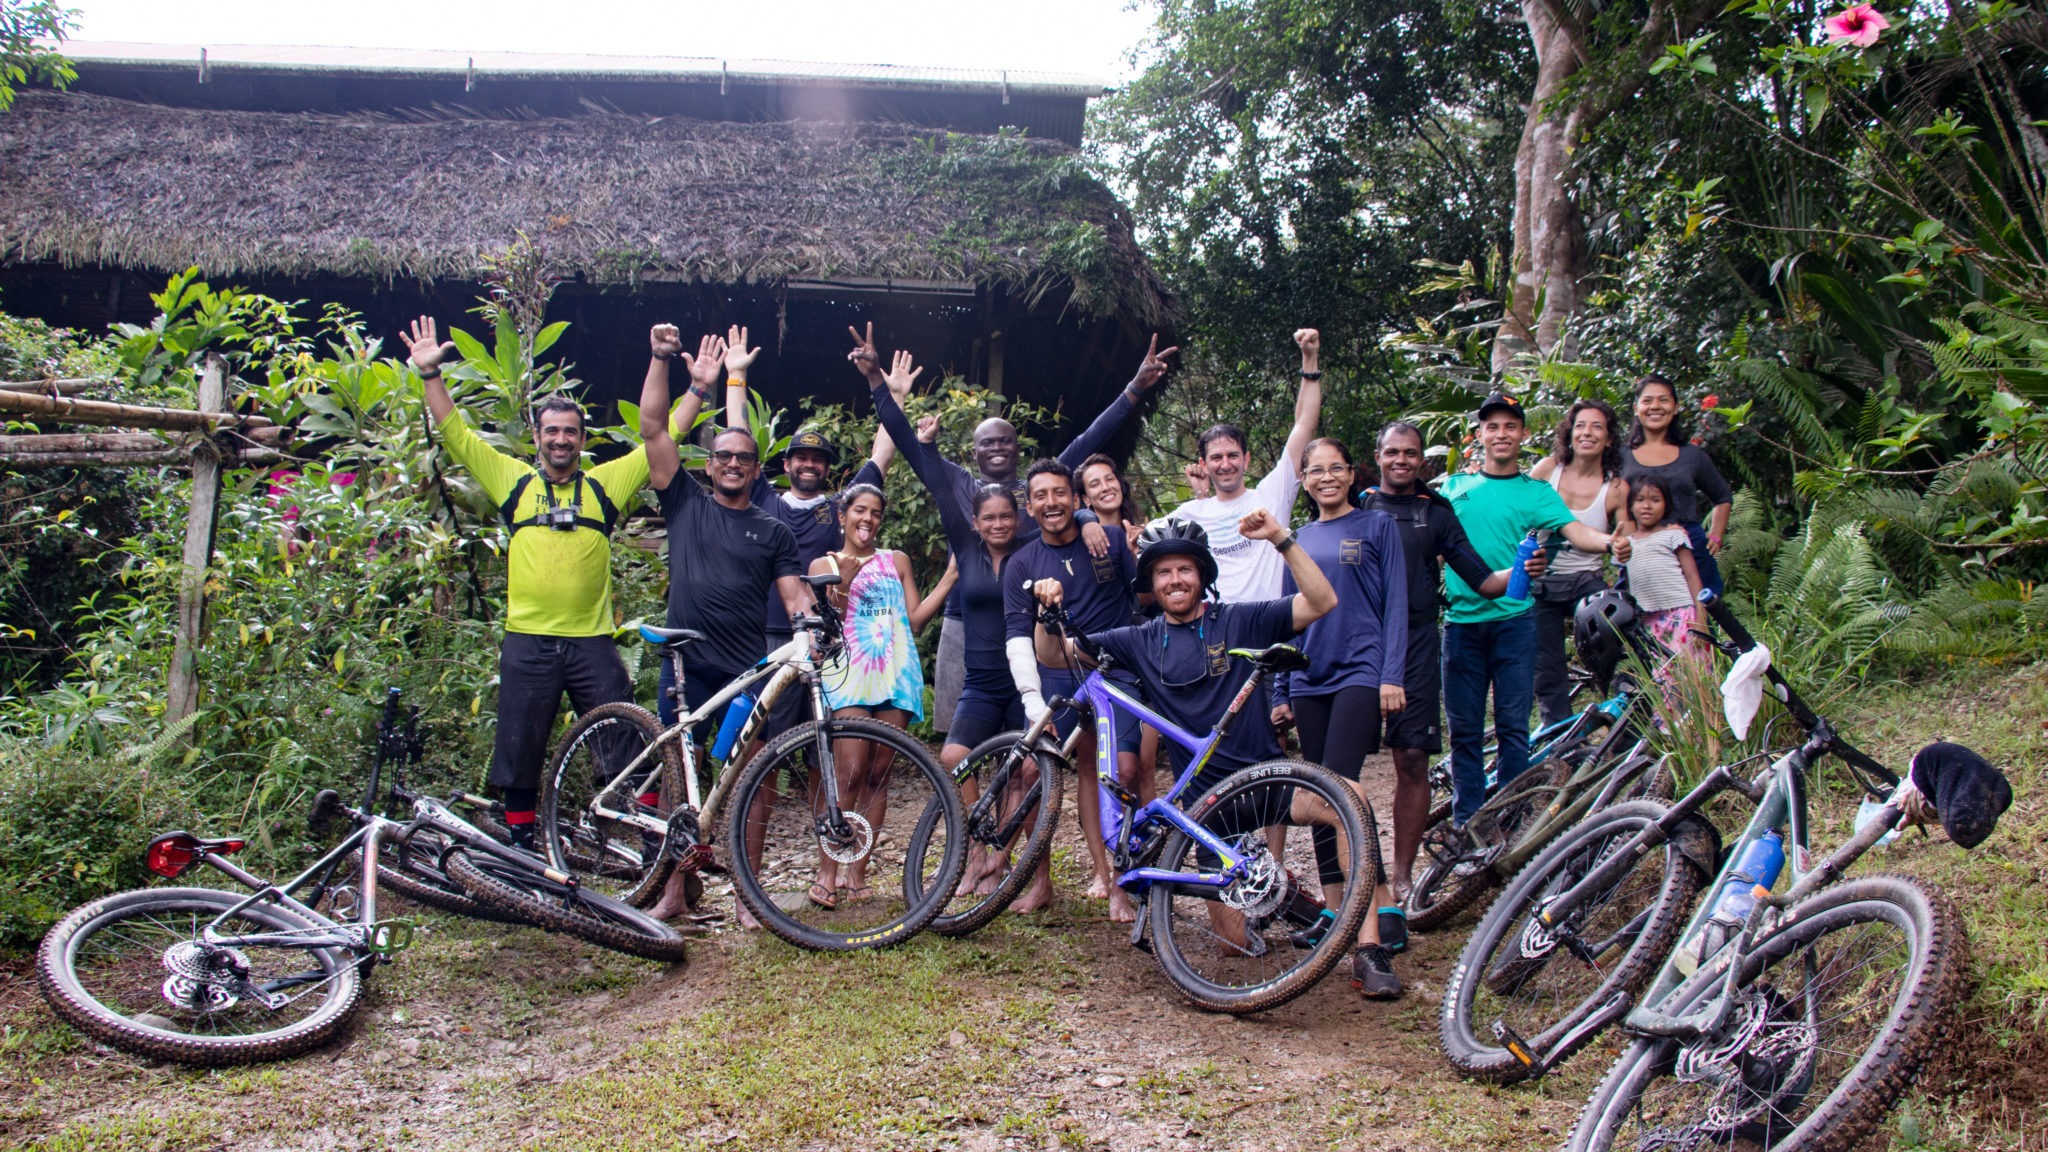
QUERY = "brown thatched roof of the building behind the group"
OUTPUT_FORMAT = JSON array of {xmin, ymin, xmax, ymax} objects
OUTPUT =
[{"xmin": 0, "ymin": 92, "xmax": 1167, "ymax": 326}]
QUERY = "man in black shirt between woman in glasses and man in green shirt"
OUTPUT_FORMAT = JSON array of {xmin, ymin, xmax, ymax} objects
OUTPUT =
[{"xmin": 1360, "ymin": 420, "xmax": 1544, "ymax": 902}]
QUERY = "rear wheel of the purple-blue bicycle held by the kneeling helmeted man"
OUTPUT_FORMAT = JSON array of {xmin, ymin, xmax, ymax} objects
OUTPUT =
[{"xmin": 1147, "ymin": 760, "xmax": 1384, "ymax": 1015}]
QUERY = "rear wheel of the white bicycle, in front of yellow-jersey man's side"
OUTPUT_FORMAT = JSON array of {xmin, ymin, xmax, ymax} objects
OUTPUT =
[{"xmin": 539, "ymin": 703, "xmax": 682, "ymax": 908}]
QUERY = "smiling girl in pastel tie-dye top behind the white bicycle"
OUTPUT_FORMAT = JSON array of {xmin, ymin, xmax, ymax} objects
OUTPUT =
[{"xmin": 811, "ymin": 484, "xmax": 952, "ymax": 908}]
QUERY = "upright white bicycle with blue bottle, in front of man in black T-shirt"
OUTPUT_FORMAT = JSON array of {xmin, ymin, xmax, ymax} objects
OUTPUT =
[{"xmin": 539, "ymin": 572, "xmax": 967, "ymax": 951}]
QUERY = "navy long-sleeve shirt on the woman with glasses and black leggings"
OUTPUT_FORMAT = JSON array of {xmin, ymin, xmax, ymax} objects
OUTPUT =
[{"xmin": 1274, "ymin": 508, "xmax": 1409, "ymax": 701}]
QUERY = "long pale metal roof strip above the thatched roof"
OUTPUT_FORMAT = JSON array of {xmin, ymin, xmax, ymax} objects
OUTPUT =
[{"xmin": 61, "ymin": 41, "xmax": 1108, "ymax": 96}]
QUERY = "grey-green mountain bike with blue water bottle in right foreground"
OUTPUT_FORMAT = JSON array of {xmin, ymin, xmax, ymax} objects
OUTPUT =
[{"xmin": 1442, "ymin": 601, "xmax": 2011, "ymax": 1150}]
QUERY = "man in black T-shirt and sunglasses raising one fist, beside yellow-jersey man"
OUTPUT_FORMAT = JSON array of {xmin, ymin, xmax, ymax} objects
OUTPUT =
[{"xmin": 641, "ymin": 324, "xmax": 811, "ymax": 920}]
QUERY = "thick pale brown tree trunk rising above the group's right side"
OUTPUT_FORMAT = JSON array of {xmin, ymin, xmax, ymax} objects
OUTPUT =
[{"xmin": 1493, "ymin": 0, "xmax": 1587, "ymax": 375}]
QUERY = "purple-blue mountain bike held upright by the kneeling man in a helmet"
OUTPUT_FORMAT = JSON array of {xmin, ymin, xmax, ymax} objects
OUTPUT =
[{"xmin": 909, "ymin": 607, "xmax": 1382, "ymax": 1015}]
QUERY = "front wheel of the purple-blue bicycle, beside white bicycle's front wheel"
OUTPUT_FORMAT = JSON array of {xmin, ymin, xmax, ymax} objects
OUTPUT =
[{"xmin": 903, "ymin": 732, "xmax": 1065, "ymax": 937}]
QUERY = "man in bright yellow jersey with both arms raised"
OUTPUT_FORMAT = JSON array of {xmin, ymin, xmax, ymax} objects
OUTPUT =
[{"xmin": 406, "ymin": 316, "xmax": 725, "ymax": 849}]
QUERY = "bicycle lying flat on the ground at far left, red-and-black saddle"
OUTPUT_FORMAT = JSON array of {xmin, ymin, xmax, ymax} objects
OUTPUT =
[{"xmin": 35, "ymin": 695, "xmax": 684, "ymax": 1064}]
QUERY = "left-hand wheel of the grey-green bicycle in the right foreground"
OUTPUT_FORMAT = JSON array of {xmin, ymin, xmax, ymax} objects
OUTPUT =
[{"xmin": 1438, "ymin": 801, "xmax": 1720, "ymax": 1084}]
